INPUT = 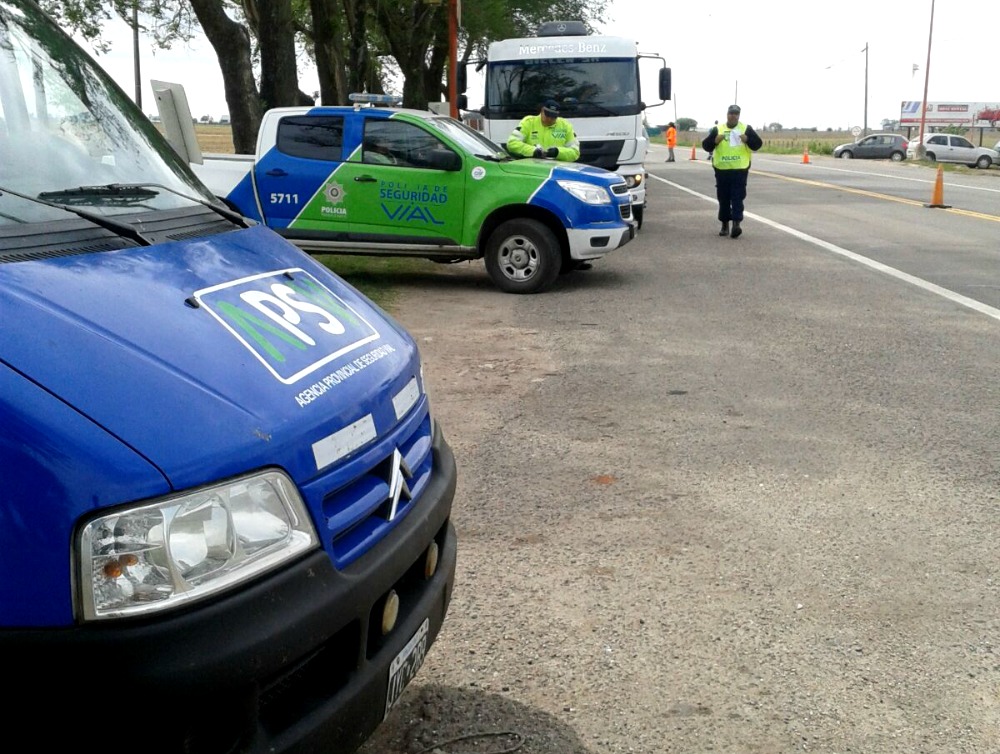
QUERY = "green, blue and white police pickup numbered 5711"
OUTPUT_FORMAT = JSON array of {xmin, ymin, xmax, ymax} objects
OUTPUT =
[{"xmin": 192, "ymin": 95, "xmax": 635, "ymax": 293}]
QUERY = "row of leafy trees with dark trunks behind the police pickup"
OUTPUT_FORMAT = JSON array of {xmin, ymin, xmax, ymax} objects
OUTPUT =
[{"xmin": 40, "ymin": 0, "xmax": 608, "ymax": 152}]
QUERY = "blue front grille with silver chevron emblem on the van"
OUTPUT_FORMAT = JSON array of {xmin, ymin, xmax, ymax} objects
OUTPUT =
[{"xmin": 310, "ymin": 404, "xmax": 433, "ymax": 569}]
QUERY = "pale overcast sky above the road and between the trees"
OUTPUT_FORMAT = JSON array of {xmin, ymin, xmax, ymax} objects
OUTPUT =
[{"xmin": 85, "ymin": 0, "xmax": 1000, "ymax": 129}]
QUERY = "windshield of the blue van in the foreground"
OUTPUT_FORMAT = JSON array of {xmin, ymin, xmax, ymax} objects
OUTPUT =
[{"xmin": 0, "ymin": 0, "xmax": 214, "ymax": 225}]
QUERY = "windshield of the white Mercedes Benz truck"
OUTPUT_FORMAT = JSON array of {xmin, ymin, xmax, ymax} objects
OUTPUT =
[{"xmin": 483, "ymin": 58, "xmax": 640, "ymax": 118}]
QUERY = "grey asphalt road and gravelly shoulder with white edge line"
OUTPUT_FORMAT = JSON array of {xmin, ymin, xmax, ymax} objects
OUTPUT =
[{"xmin": 362, "ymin": 148, "xmax": 1000, "ymax": 754}]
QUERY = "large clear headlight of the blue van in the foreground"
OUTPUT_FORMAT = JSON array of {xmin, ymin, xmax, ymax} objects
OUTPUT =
[{"xmin": 79, "ymin": 471, "xmax": 319, "ymax": 620}]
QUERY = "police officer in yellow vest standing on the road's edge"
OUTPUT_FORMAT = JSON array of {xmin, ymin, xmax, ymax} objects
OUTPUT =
[{"xmin": 701, "ymin": 105, "xmax": 764, "ymax": 238}]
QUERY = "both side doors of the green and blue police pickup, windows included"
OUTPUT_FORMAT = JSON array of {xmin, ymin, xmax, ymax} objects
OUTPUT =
[{"xmin": 257, "ymin": 109, "xmax": 465, "ymax": 245}]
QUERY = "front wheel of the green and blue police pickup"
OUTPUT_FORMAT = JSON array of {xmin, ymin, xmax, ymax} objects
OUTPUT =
[{"xmin": 486, "ymin": 220, "xmax": 561, "ymax": 293}]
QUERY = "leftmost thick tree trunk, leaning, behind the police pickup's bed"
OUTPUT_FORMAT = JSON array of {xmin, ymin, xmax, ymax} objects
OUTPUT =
[{"xmin": 191, "ymin": 0, "xmax": 263, "ymax": 154}]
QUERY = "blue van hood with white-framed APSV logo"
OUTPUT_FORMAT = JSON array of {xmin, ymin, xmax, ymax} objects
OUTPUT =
[{"xmin": 0, "ymin": 227, "xmax": 422, "ymax": 489}]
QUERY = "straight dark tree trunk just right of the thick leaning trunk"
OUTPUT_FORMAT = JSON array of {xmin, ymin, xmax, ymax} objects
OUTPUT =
[{"xmin": 257, "ymin": 0, "xmax": 299, "ymax": 109}]
